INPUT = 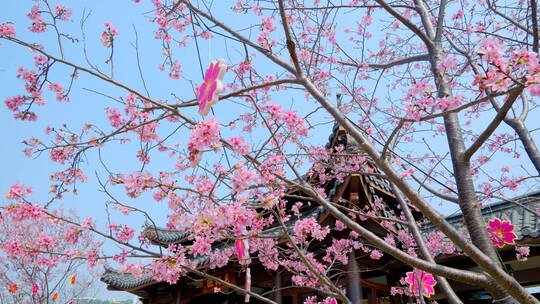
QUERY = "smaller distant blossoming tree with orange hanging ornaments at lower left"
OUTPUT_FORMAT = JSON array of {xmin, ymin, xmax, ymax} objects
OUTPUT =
[{"xmin": 0, "ymin": 198, "xmax": 99, "ymax": 304}]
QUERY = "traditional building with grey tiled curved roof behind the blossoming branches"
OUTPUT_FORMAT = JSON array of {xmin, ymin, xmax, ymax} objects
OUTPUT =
[{"xmin": 101, "ymin": 126, "xmax": 540, "ymax": 304}]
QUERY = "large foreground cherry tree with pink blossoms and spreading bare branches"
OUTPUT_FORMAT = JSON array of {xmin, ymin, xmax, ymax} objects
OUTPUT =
[{"xmin": 0, "ymin": 0, "xmax": 540, "ymax": 303}]
